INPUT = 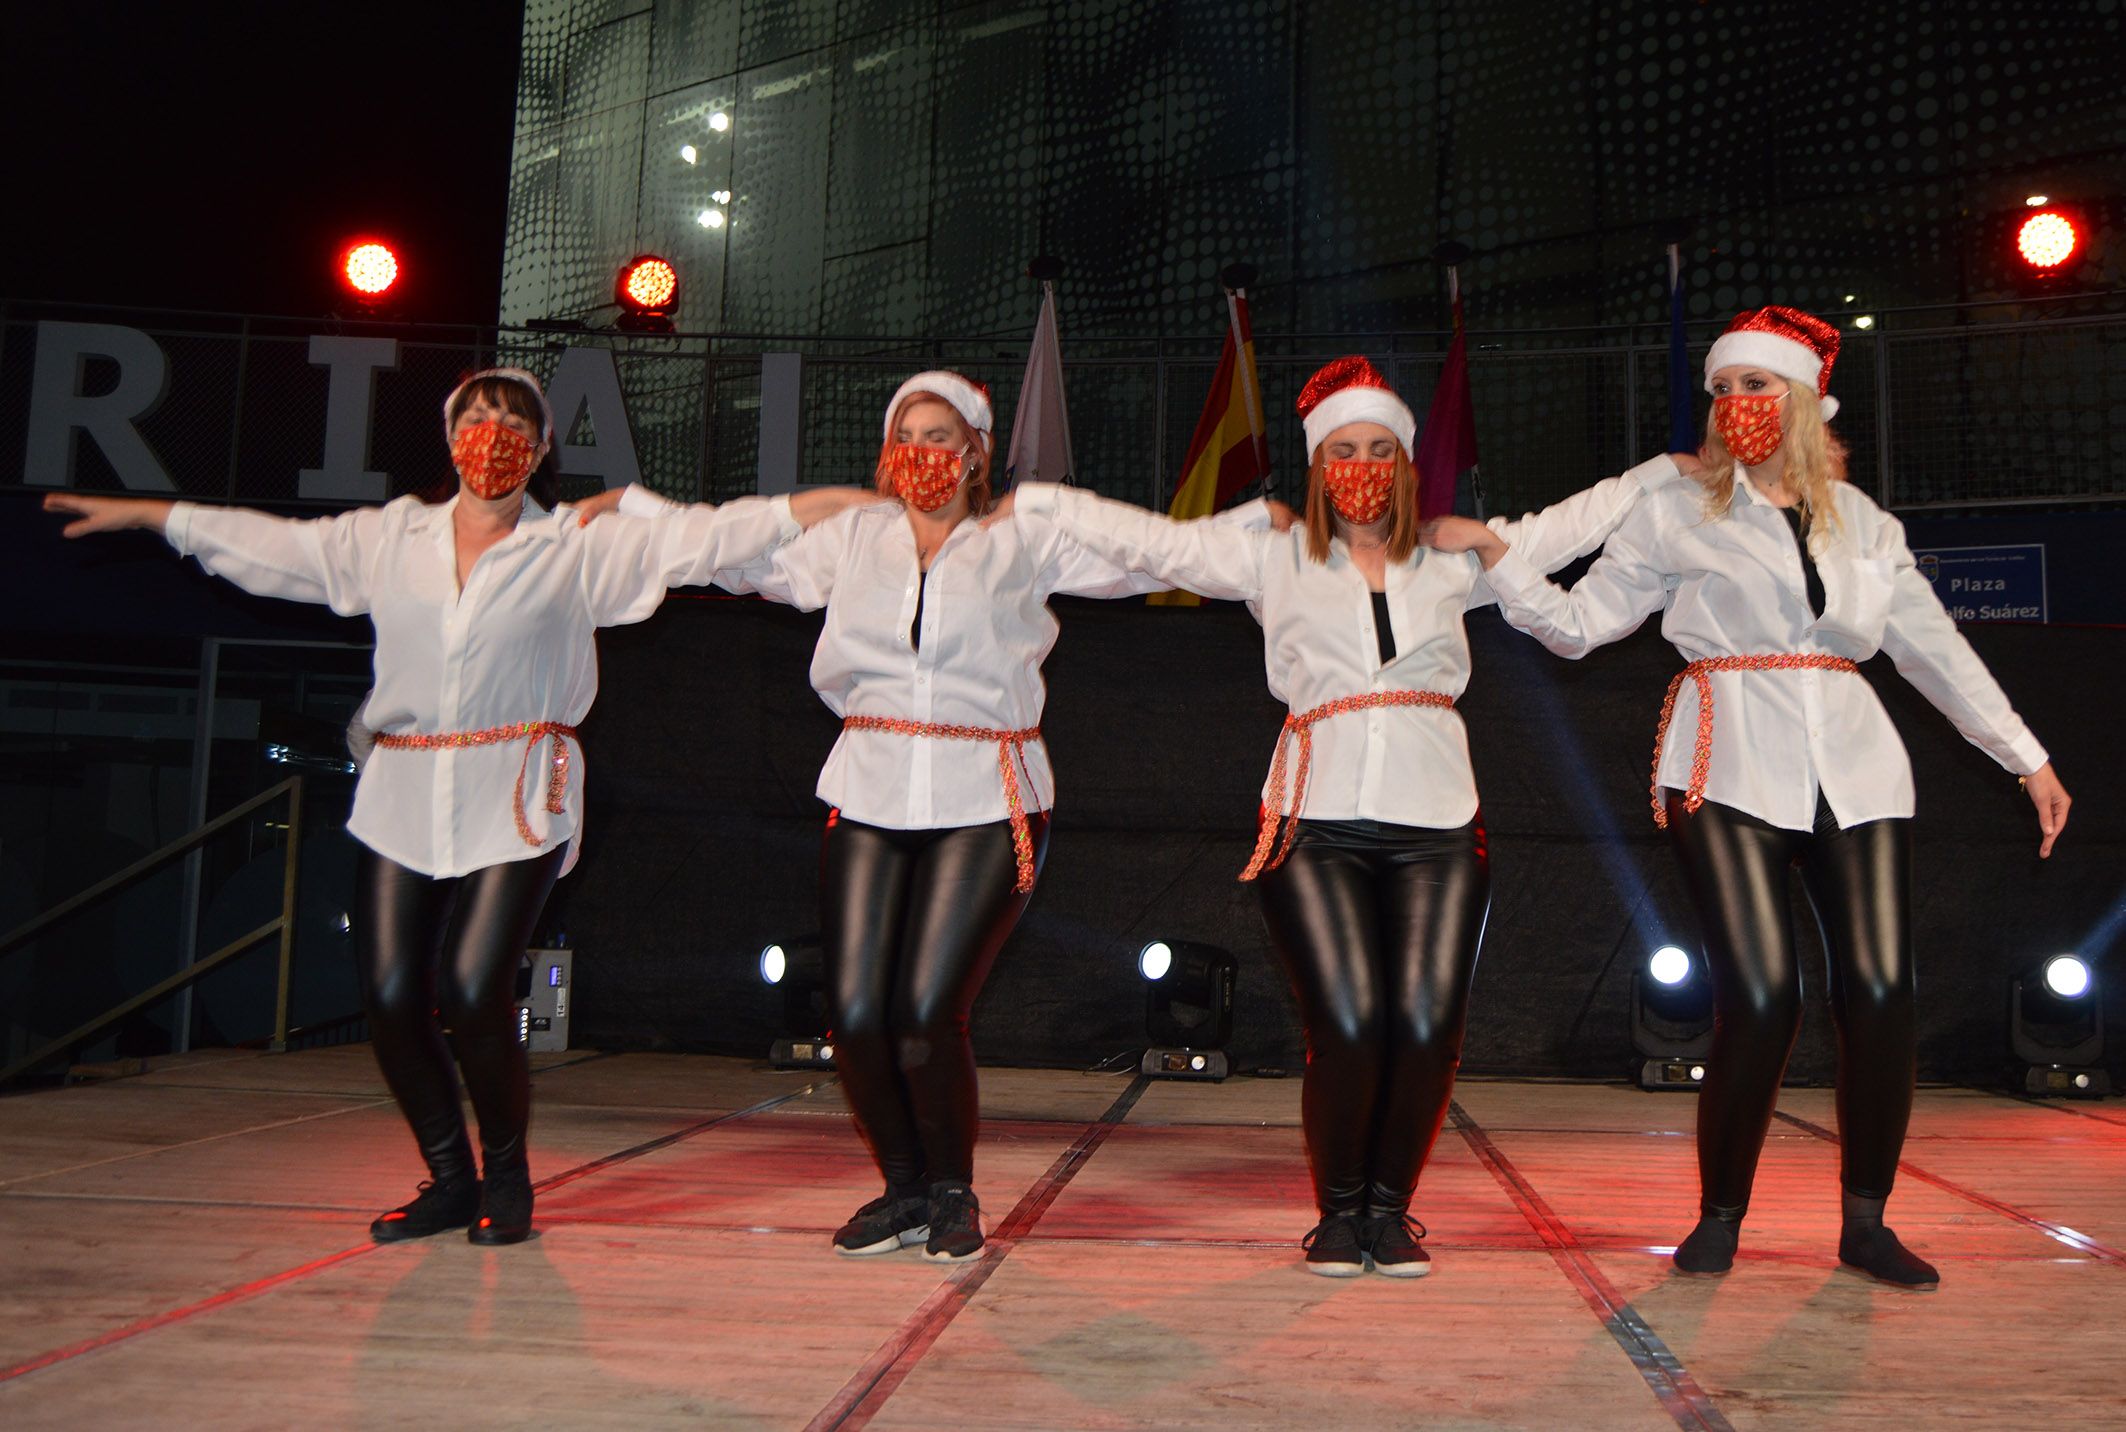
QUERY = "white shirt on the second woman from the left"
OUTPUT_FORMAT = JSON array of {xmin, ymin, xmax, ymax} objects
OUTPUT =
[{"xmin": 621, "ymin": 487, "xmax": 1269, "ymax": 831}]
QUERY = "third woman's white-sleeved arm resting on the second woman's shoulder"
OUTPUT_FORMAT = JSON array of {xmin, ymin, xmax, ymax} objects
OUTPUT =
[{"xmin": 1012, "ymin": 482, "xmax": 1276, "ymax": 601}]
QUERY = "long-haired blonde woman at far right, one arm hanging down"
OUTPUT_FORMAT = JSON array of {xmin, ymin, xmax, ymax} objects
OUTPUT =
[{"xmin": 1431, "ymin": 306, "xmax": 2069, "ymax": 1288}]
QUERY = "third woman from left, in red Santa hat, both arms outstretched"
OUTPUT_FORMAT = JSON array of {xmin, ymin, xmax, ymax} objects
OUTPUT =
[{"xmin": 1014, "ymin": 357, "xmax": 1677, "ymax": 1277}]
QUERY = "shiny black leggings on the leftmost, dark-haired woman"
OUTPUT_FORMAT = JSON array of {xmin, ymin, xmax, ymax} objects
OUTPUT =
[{"xmin": 353, "ymin": 846, "xmax": 568, "ymax": 1181}]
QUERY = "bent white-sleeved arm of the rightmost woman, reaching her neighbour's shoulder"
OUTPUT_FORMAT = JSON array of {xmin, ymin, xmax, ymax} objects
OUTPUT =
[{"xmin": 1424, "ymin": 504, "xmax": 1669, "ymax": 659}]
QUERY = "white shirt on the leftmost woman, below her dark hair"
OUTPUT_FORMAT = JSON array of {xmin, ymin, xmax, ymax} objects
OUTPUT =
[{"xmin": 164, "ymin": 497, "xmax": 797, "ymax": 877}]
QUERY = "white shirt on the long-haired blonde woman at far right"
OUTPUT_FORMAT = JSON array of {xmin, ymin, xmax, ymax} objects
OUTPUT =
[{"xmin": 1490, "ymin": 467, "xmax": 2045, "ymax": 831}]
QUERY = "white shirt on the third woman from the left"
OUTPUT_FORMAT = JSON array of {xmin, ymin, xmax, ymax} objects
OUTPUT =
[{"xmin": 1014, "ymin": 457, "xmax": 1675, "ymax": 829}]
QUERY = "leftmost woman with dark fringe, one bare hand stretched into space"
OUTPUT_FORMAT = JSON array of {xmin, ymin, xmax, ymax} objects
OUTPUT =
[{"xmin": 45, "ymin": 368, "xmax": 853, "ymax": 1243}]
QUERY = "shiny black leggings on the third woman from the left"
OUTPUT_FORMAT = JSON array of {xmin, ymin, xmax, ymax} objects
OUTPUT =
[{"xmin": 1259, "ymin": 820, "xmax": 1490, "ymax": 1217}]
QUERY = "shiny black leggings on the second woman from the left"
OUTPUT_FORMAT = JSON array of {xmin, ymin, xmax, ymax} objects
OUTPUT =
[{"xmin": 821, "ymin": 812, "xmax": 1048, "ymax": 1190}]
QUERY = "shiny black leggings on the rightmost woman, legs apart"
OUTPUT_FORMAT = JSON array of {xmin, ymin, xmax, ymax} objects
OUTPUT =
[{"xmin": 1667, "ymin": 790, "xmax": 1916, "ymax": 1217}]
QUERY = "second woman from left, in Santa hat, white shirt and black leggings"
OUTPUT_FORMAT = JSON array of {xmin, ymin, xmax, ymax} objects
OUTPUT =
[{"xmin": 602, "ymin": 372, "xmax": 1259, "ymax": 1262}]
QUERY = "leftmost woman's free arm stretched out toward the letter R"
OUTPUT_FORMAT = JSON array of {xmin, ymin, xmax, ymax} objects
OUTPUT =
[{"xmin": 45, "ymin": 493, "xmax": 383, "ymax": 616}]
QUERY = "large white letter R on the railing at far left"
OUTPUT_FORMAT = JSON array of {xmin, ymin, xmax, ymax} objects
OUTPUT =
[{"xmin": 21, "ymin": 323, "xmax": 176, "ymax": 493}]
